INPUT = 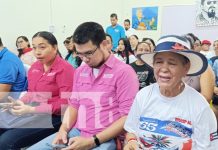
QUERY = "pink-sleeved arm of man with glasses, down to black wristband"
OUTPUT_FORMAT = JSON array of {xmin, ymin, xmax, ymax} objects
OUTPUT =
[{"xmin": 97, "ymin": 66, "xmax": 139, "ymax": 143}]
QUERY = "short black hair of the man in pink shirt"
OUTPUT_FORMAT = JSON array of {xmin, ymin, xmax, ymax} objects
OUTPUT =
[{"xmin": 73, "ymin": 22, "xmax": 106, "ymax": 46}]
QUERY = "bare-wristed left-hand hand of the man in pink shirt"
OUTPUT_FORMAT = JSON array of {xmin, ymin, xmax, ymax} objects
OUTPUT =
[{"xmin": 52, "ymin": 127, "xmax": 68, "ymax": 145}]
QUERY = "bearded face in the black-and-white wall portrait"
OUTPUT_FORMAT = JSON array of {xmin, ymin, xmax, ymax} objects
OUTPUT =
[{"xmin": 201, "ymin": 0, "xmax": 218, "ymax": 18}]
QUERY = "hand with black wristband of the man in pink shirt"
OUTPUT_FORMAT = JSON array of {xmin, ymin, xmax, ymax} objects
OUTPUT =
[{"xmin": 62, "ymin": 136, "xmax": 95, "ymax": 150}]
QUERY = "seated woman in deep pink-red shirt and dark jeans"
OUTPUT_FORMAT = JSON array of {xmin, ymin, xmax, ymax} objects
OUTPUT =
[{"xmin": 0, "ymin": 31, "xmax": 74, "ymax": 150}]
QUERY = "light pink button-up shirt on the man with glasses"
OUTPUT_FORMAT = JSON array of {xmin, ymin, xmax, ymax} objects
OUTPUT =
[{"xmin": 69, "ymin": 55, "xmax": 139, "ymax": 137}]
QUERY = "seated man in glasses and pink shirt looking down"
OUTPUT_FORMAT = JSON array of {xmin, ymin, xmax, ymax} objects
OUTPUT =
[{"xmin": 29, "ymin": 22, "xmax": 139, "ymax": 150}]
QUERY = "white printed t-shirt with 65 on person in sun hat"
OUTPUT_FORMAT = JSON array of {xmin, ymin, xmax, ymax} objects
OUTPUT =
[{"xmin": 124, "ymin": 83, "xmax": 218, "ymax": 150}]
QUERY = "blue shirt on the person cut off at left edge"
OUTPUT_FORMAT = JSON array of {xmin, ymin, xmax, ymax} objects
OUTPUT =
[{"xmin": 0, "ymin": 48, "xmax": 27, "ymax": 92}]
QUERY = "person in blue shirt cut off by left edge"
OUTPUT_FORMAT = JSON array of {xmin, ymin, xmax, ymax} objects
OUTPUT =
[{"xmin": 0, "ymin": 38, "xmax": 27, "ymax": 102}]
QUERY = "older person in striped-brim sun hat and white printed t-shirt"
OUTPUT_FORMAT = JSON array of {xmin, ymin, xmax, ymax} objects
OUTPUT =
[{"xmin": 124, "ymin": 35, "xmax": 218, "ymax": 150}]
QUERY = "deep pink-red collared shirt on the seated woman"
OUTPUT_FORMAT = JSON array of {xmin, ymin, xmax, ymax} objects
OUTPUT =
[{"xmin": 21, "ymin": 55, "xmax": 74, "ymax": 115}]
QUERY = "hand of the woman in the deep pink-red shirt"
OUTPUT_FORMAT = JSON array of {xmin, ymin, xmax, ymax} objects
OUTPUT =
[{"xmin": 10, "ymin": 100, "xmax": 35, "ymax": 116}]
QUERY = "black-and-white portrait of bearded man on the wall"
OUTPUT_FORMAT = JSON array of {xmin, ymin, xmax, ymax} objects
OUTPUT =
[{"xmin": 196, "ymin": 0, "xmax": 218, "ymax": 26}]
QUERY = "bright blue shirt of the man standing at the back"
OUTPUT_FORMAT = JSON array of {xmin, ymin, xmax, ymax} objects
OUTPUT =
[{"xmin": 106, "ymin": 24, "xmax": 126, "ymax": 51}]
